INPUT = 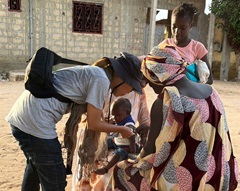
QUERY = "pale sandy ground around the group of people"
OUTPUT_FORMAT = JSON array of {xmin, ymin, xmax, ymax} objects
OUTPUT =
[{"xmin": 0, "ymin": 81, "xmax": 240, "ymax": 191}]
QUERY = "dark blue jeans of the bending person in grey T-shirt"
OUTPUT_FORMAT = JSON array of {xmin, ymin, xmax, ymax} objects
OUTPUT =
[{"xmin": 11, "ymin": 125, "xmax": 67, "ymax": 191}]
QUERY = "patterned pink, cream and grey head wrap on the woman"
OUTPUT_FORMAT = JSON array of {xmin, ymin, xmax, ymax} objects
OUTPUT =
[{"xmin": 141, "ymin": 46, "xmax": 187, "ymax": 85}]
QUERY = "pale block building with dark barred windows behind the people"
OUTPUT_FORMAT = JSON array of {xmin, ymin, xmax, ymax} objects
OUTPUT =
[{"xmin": 0, "ymin": 0, "xmax": 208, "ymax": 72}]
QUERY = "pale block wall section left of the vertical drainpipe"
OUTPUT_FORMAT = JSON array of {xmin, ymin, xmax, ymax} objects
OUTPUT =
[{"xmin": 0, "ymin": 0, "xmax": 29, "ymax": 70}]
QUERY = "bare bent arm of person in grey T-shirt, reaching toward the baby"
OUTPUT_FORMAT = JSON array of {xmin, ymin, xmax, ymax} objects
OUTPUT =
[{"xmin": 87, "ymin": 104, "xmax": 133, "ymax": 138}]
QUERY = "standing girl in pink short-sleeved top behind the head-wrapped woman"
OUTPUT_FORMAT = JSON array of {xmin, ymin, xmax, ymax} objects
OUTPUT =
[{"xmin": 158, "ymin": 3, "xmax": 213, "ymax": 84}]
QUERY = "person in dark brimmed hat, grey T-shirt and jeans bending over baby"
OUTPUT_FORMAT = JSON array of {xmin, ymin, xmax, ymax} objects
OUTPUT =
[{"xmin": 6, "ymin": 52, "xmax": 142, "ymax": 191}]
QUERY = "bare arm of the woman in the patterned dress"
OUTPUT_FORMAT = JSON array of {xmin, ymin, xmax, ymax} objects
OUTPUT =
[{"xmin": 140, "ymin": 98, "xmax": 163, "ymax": 158}]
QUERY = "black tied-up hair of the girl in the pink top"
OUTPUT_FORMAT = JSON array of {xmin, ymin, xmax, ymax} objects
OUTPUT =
[{"xmin": 172, "ymin": 3, "xmax": 198, "ymax": 22}]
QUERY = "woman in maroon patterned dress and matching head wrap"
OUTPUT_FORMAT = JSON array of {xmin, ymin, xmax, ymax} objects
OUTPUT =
[{"xmin": 107, "ymin": 47, "xmax": 238, "ymax": 191}]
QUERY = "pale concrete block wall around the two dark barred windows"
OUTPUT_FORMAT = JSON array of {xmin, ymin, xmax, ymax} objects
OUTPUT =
[{"xmin": 0, "ymin": 0, "xmax": 147, "ymax": 70}]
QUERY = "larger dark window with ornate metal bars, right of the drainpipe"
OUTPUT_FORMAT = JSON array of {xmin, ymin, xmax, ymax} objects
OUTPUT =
[{"xmin": 73, "ymin": 1, "xmax": 103, "ymax": 34}]
